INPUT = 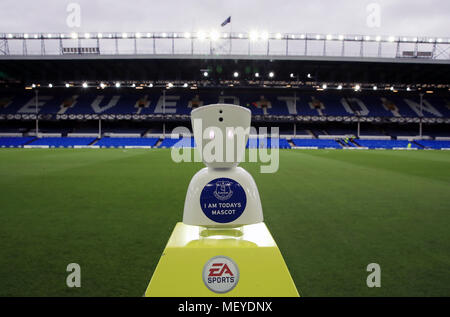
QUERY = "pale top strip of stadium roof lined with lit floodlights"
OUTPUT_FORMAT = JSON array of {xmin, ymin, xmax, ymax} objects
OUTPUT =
[{"xmin": 0, "ymin": 29, "xmax": 450, "ymax": 60}]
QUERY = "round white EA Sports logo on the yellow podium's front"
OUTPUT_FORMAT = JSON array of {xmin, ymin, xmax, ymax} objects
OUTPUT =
[{"xmin": 203, "ymin": 255, "xmax": 239, "ymax": 293}]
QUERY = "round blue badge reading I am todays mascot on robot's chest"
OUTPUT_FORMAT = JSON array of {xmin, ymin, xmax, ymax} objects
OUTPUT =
[{"xmin": 200, "ymin": 178, "xmax": 247, "ymax": 223}]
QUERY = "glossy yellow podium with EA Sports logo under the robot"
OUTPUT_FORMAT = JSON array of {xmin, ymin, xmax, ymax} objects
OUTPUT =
[{"xmin": 145, "ymin": 222, "xmax": 299, "ymax": 297}]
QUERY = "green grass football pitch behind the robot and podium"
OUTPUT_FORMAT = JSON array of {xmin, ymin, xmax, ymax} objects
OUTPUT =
[{"xmin": 0, "ymin": 149, "xmax": 450, "ymax": 296}]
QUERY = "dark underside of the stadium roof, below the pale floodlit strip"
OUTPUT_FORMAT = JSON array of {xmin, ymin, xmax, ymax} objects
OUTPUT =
[{"xmin": 0, "ymin": 58, "xmax": 450, "ymax": 87}]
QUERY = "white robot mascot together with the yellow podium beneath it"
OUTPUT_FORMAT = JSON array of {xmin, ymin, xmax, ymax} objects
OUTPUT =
[{"xmin": 145, "ymin": 104, "xmax": 299, "ymax": 297}]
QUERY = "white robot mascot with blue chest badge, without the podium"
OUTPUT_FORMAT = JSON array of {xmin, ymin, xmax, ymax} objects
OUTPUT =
[{"xmin": 183, "ymin": 104, "xmax": 263, "ymax": 227}]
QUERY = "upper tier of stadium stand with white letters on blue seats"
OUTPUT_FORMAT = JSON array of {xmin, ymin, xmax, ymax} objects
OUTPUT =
[{"xmin": 0, "ymin": 91, "xmax": 450, "ymax": 119}]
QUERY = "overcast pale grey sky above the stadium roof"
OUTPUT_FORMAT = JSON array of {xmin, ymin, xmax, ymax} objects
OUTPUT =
[{"xmin": 0, "ymin": 0, "xmax": 450, "ymax": 37}]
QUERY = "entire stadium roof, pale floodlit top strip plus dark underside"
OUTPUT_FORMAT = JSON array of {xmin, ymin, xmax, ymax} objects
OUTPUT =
[{"xmin": 0, "ymin": 32, "xmax": 450, "ymax": 89}]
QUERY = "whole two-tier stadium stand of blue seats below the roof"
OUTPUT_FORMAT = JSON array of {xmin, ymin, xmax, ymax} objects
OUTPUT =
[{"xmin": 0, "ymin": 88, "xmax": 450, "ymax": 149}]
